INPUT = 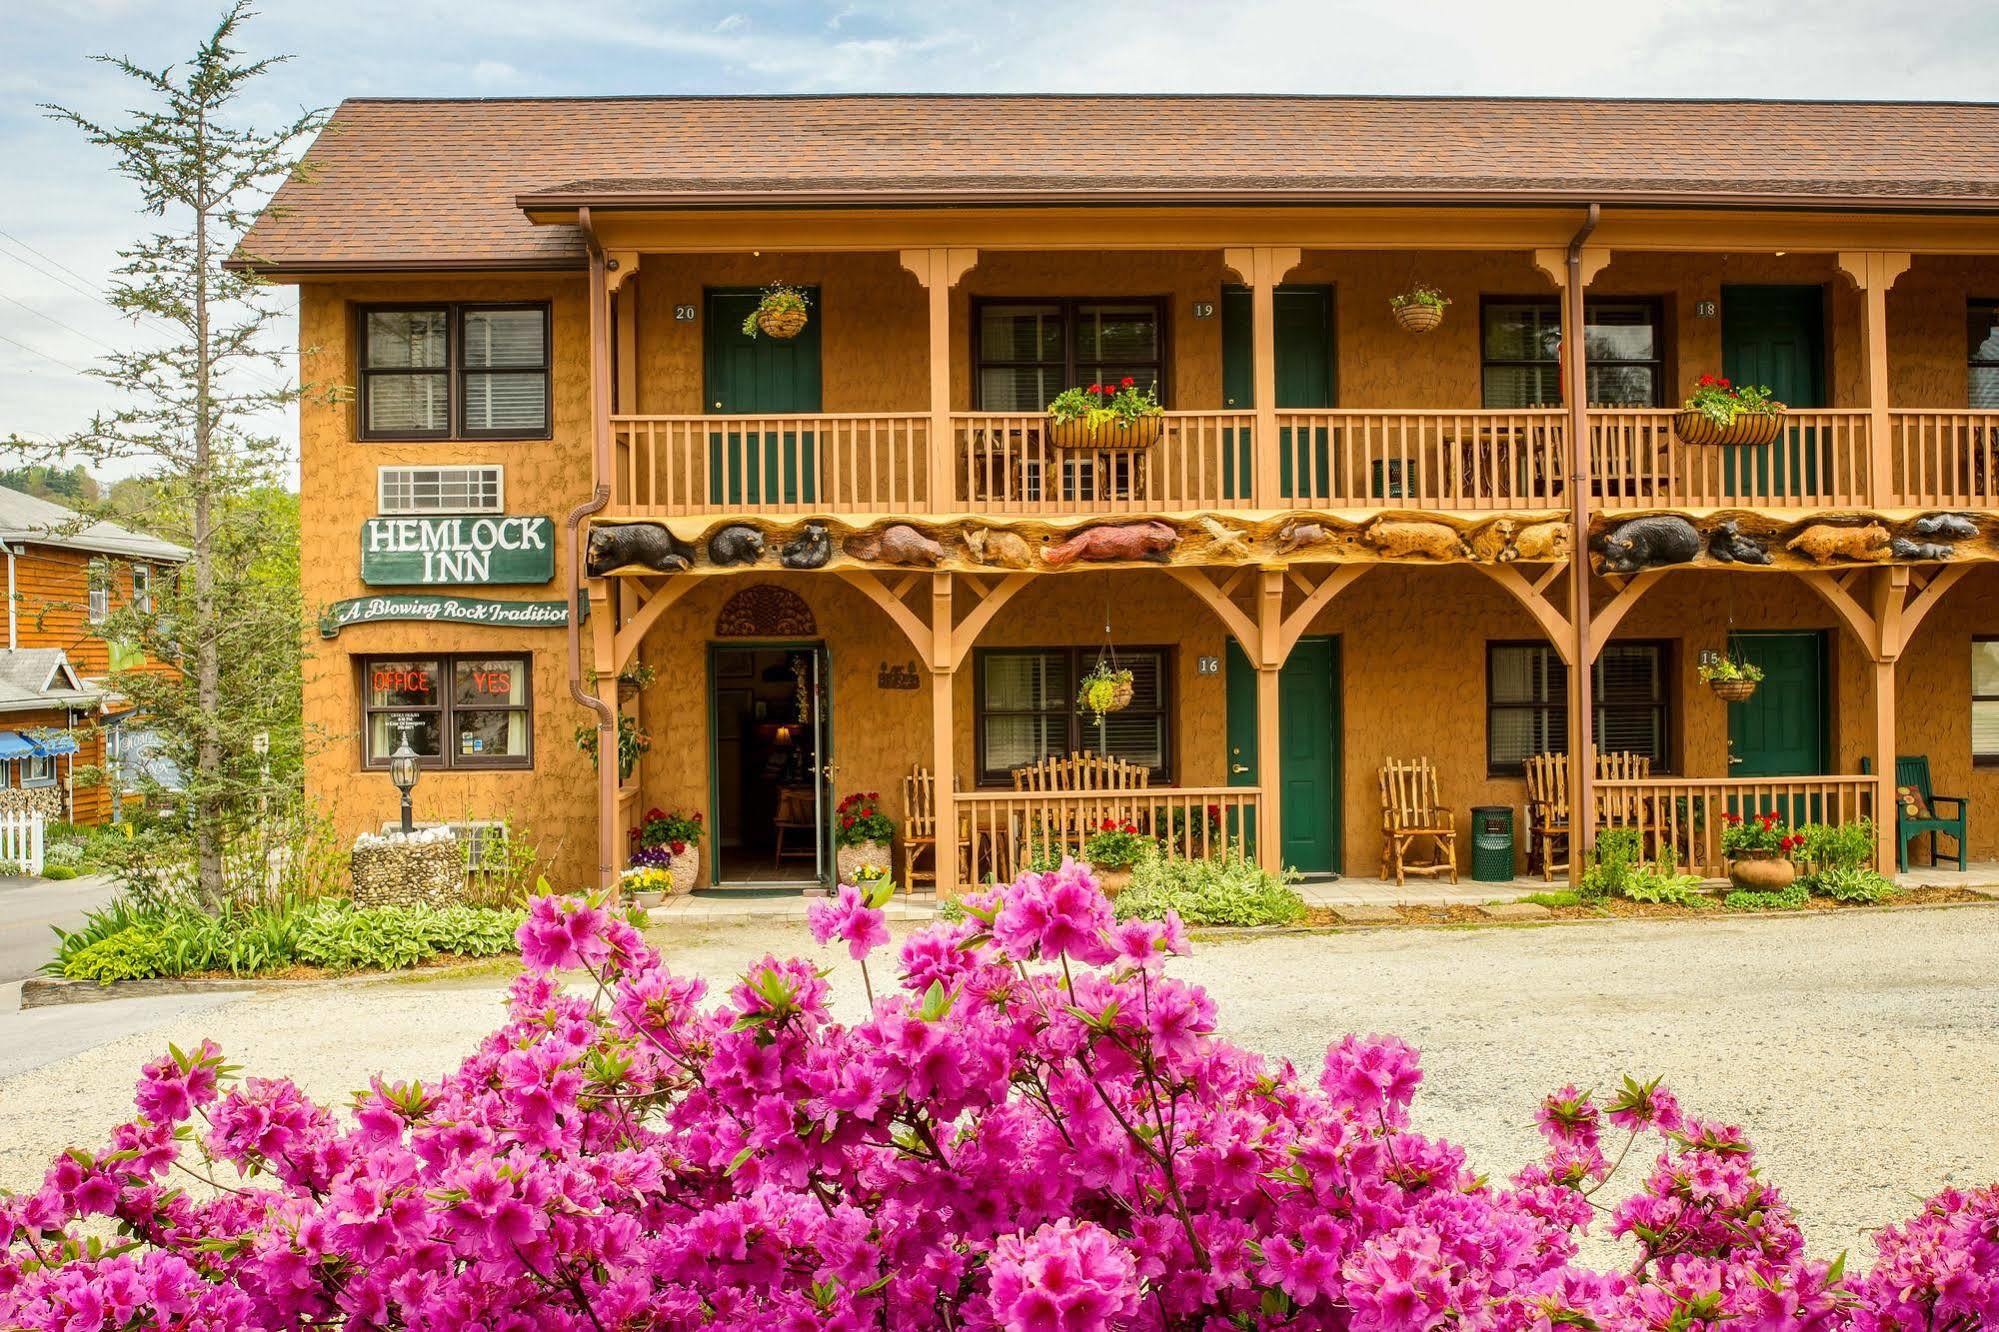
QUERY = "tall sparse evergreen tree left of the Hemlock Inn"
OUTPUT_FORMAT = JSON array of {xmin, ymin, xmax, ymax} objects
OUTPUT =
[{"xmin": 46, "ymin": 0, "xmax": 324, "ymax": 906}]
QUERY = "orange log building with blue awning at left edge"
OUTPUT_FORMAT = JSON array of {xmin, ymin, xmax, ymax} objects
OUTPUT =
[{"xmin": 0, "ymin": 488, "xmax": 188, "ymax": 826}]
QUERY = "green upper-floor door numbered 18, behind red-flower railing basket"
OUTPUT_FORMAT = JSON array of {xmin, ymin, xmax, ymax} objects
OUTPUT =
[{"xmin": 1721, "ymin": 286, "xmax": 1829, "ymax": 496}]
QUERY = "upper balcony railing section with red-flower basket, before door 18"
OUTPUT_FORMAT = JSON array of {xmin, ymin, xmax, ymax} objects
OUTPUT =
[{"xmin": 1589, "ymin": 408, "xmax": 1869, "ymax": 510}]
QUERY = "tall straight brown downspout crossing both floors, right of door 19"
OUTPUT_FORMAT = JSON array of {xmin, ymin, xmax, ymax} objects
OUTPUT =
[{"xmin": 1561, "ymin": 204, "xmax": 1601, "ymax": 884}]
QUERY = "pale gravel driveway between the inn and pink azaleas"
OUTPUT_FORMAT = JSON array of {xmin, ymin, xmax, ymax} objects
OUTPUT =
[{"xmin": 0, "ymin": 908, "xmax": 1999, "ymax": 1262}]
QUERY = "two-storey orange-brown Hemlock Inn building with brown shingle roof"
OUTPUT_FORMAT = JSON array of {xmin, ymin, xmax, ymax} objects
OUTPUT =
[{"xmin": 234, "ymin": 96, "xmax": 1999, "ymax": 890}]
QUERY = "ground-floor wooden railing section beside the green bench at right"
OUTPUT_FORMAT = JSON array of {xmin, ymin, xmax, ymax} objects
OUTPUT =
[{"xmin": 1593, "ymin": 776, "xmax": 1879, "ymax": 878}]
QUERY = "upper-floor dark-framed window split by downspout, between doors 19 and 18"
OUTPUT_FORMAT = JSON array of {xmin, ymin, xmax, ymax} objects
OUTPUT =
[{"xmin": 1481, "ymin": 298, "xmax": 1661, "ymax": 408}]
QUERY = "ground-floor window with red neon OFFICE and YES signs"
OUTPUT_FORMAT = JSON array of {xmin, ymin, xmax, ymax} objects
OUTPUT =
[{"xmin": 362, "ymin": 656, "xmax": 534, "ymax": 768}]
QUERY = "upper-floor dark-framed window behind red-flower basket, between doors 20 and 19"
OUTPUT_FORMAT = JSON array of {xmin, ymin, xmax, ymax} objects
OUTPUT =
[{"xmin": 974, "ymin": 300, "xmax": 1165, "ymax": 412}]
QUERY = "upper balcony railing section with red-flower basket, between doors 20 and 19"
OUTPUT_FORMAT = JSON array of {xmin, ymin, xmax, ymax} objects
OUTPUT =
[{"xmin": 952, "ymin": 412, "xmax": 1255, "ymax": 514}]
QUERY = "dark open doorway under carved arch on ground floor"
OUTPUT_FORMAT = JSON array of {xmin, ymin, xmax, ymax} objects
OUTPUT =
[{"xmin": 708, "ymin": 644, "xmax": 832, "ymax": 888}]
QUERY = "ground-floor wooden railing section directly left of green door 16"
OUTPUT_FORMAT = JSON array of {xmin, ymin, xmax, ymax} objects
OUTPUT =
[{"xmin": 956, "ymin": 786, "xmax": 1261, "ymax": 882}]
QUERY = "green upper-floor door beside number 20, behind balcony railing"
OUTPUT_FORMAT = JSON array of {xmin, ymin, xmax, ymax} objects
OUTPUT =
[{"xmin": 704, "ymin": 288, "xmax": 822, "ymax": 504}]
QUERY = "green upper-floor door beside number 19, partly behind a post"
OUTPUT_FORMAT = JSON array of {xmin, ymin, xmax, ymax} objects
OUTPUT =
[{"xmin": 1221, "ymin": 286, "xmax": 1333, "ymax": 500}]
